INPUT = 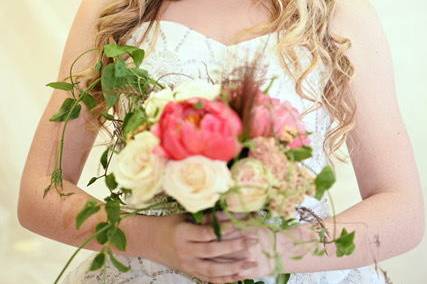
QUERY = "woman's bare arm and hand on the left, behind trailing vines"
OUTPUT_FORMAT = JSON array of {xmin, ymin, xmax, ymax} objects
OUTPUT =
[{"xmin": 18, "ymin": 0, "xmax": 254, "ymax": 279}]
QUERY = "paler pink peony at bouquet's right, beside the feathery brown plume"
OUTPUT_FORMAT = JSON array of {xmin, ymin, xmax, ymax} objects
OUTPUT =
[{"xmin": 251, "ymin": 95, "xmax": 310, "ymax": 148}]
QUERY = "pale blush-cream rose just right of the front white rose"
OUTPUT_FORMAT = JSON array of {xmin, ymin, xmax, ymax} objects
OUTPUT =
[{"xmin": 226, "ymin": 158, "xmax": 272, "ymax": 213}]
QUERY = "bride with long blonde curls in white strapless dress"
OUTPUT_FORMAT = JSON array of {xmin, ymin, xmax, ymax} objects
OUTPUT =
[{"xmin": 18, "ymin": 0, "xmax": 424, "ymax": 284}]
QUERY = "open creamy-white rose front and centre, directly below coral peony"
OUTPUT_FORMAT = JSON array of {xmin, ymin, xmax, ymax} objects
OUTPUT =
[{"xmin": 163, "ymin": 156, "xmax": 232, "ymax": 213}]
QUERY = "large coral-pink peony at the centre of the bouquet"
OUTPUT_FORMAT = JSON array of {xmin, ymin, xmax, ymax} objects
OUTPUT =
[{"xmin": 156, "ymin": 98, "xmax": 242, "ymax": 161}]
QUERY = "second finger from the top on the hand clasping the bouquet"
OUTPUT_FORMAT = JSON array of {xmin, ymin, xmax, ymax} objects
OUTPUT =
[{"xmin": 191, "ymin": 238, "xmax": 258, "ymax": 258}]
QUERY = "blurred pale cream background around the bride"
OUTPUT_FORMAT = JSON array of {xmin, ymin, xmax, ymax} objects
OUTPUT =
[{"xmin": 0, "ymin": 0, "xmax": 427, "ymax": 284}]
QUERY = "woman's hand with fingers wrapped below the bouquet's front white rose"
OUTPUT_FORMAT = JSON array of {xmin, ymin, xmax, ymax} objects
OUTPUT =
[{"xmin": 159, "ymin": 218, "xmax": 257, "ymax": 283}]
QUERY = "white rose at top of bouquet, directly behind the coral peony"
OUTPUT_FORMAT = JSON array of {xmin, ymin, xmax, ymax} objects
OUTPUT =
[{"xmin": 175, "ymin": 80, "xmax": 221, "ymax": 101}]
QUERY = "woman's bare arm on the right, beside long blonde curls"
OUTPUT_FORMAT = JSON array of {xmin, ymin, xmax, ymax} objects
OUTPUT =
[{"xmin": 243, "ymin": 0, "xmax": 424, "ymax": 277}]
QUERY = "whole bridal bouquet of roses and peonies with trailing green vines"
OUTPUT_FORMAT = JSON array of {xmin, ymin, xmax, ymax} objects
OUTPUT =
[{"xmin": 46, "ymin": 44, "xmax": 355, "ymax": 283}]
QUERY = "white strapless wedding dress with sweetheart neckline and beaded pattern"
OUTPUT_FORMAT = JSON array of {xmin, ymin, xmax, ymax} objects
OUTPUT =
[{"xmin": 64, "ymin": 21, "xmax": 384, "ymax": 284}]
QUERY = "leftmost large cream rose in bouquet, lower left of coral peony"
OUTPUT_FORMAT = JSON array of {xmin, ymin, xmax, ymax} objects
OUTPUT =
[{"xmin": 113, "ymin": 131, "xmax": 165, "ymax": 208}]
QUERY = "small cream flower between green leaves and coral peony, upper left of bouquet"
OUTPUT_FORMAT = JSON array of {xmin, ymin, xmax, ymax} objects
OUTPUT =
[{"xmin": 144, "ymin": 88, "xmax": 174, "ymax": 122}]
